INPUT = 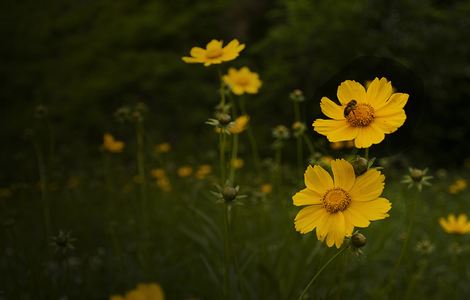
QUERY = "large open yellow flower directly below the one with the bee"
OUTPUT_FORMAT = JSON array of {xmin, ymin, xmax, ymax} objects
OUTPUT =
[{"xmin": 292, "ymin": 159, "xmax": 391, "ymax": 248}]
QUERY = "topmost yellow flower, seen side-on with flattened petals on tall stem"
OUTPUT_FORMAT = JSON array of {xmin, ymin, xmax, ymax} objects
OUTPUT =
[{"xmin": 183, "ymin": 39, "xmax": 245, "ymax": 67}]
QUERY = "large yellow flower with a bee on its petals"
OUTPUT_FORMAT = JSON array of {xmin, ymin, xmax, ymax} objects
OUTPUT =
[{"xmin": 313, "ymin": 78, "xmax": 409, "ymax": 148}]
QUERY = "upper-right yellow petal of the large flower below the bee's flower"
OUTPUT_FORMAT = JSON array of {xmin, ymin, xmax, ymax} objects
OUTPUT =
[{"xmin": 349, "ymin": 169, "xmax": 385, "ymax": 201}]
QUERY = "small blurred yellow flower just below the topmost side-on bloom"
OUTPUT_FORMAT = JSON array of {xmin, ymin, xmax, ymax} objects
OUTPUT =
[{"xmin": 223, "ymin": 67, "xmax": 262, "ymax": 95}]
